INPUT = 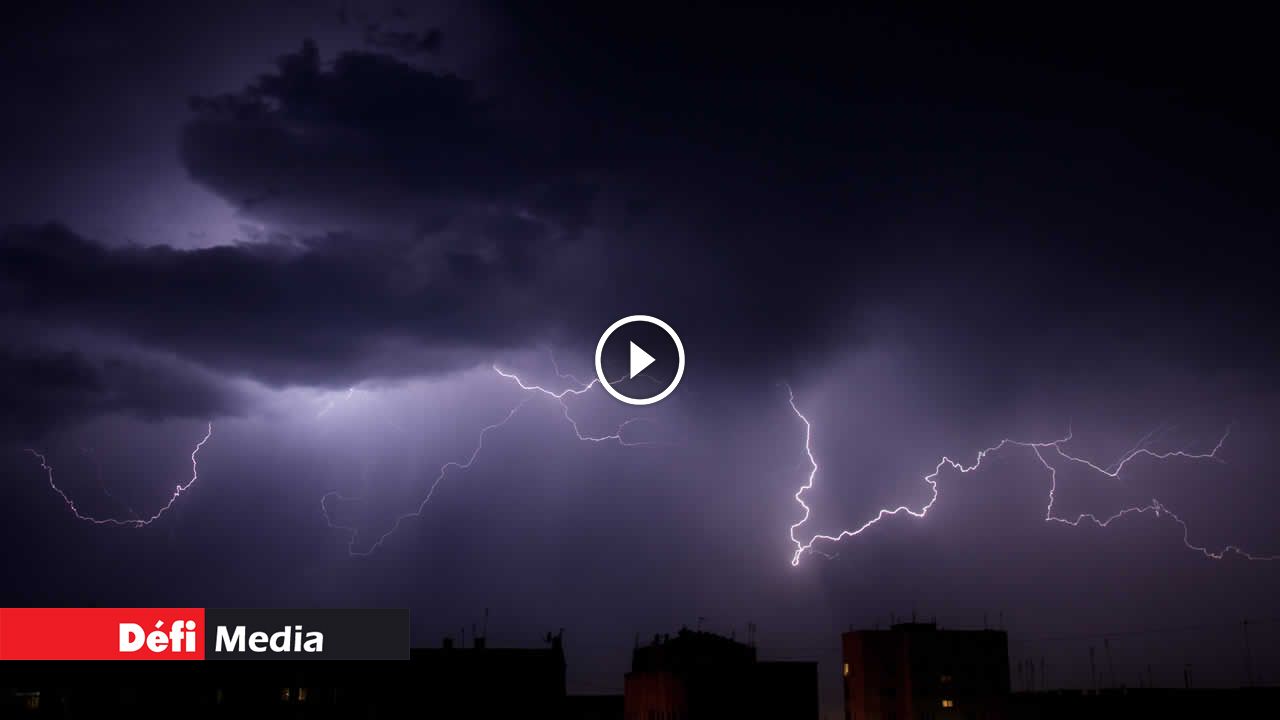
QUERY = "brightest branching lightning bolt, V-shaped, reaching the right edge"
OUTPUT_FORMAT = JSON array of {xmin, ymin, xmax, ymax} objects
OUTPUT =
[{"xmin": 785, "ymin": 386, "xmax": 1280, "ymax": 566}]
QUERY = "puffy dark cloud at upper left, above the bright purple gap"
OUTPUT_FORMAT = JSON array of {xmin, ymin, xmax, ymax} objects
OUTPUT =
[{"xmin": 180, "ymin": 41, "xmax": 579, "ymax": 229}]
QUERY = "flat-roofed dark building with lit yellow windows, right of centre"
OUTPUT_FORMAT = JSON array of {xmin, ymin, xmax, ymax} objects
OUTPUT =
[{"xmin": 841, "ymin": 623, "xmax": 1010, "ymax": 720}]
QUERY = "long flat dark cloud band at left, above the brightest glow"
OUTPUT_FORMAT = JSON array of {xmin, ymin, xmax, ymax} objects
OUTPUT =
[{"xmin": 0, "ymin": 225, "xmax": 568, "ymax": 384}]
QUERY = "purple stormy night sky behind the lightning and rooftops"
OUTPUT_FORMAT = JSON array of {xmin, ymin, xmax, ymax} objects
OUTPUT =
[{"xmin": 0, "ymin": 0, "xmax": 1280, "ymax": 707}]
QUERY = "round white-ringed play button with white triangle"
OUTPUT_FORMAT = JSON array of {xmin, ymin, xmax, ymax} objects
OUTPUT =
[{"xmin": 595, "ymin": 315, "xmax": 685, "ymax": 405}]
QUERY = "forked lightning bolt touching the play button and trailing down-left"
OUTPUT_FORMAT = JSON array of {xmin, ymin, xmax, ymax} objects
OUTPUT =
[{"xmin": 320, "ymin": 350, "xmax": 655, "ymax": 557}]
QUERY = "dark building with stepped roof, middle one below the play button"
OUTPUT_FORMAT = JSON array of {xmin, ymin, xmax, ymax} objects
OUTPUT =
[{"xmin": 623, "ymin": 628, "xmax": 818, "ymax": 720}]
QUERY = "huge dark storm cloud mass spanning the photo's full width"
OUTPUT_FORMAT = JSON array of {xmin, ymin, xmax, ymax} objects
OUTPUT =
[{"xmin": 0, "ymin": 13, "xmax": 1275, "ymax": 427}]
